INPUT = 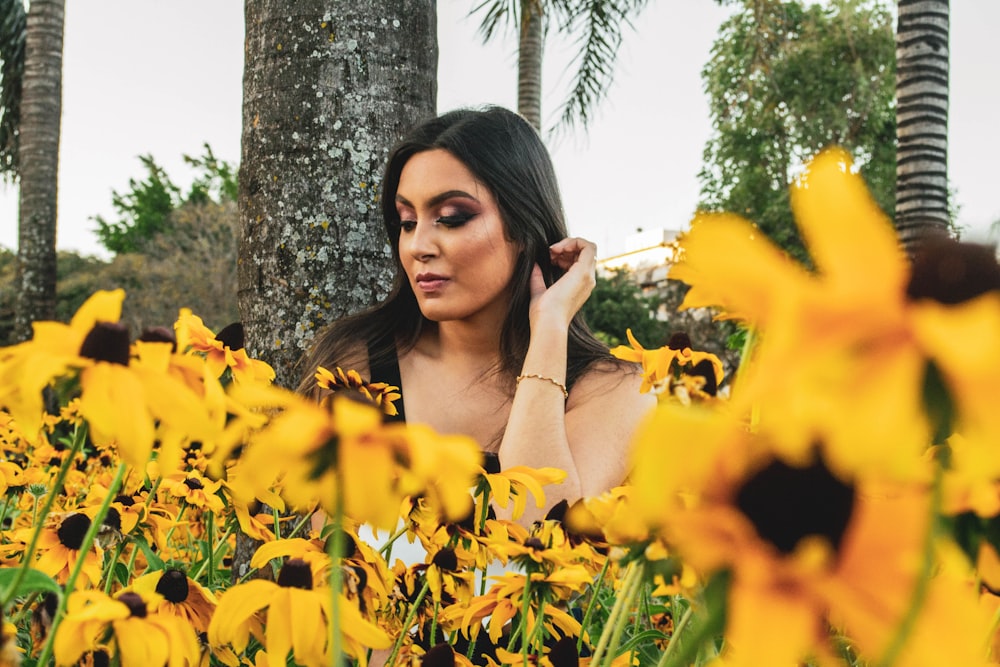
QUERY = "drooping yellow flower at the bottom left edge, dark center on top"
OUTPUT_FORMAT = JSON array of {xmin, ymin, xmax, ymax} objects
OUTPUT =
[{"xmin": 54, "ymin": 591, "xmax": 199, "ymax": 667}]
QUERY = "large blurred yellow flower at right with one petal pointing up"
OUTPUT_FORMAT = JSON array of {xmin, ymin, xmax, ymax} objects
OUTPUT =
[{"xmin": 670, "ymin": 150, "xmax": 931, "ymax": 479}]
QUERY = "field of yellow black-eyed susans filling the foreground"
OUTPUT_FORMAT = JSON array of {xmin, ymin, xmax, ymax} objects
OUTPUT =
[{"xmin": 0, "ymin": 150, "xmax": 1000, "ymax": 667}]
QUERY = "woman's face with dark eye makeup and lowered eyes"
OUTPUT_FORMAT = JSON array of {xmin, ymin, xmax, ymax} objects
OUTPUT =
[{"xmin": 396, "ymin": 149, "xmax": 518, "ymax": 327}]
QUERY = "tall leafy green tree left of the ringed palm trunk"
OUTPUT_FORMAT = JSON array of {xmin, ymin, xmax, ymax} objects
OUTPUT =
[{"xmin": 699, "ymin": 0, "xmax": 896, "ymax": 259}]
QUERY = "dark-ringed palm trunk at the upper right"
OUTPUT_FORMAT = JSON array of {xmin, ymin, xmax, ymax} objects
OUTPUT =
[{"xmin": 896, "ymin": 0, "xmax": 950, "ymax": 255}]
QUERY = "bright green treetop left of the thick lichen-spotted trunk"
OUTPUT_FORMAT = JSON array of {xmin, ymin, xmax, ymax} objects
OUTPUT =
[{"xmin": 94, "ymin": 143, "xmax": 237, "ymax": 255}]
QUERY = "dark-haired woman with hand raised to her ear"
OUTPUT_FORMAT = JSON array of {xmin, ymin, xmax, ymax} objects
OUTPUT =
[{"xmin": 300, "ymin": 107, "xmax": 655, "ymax": 521}]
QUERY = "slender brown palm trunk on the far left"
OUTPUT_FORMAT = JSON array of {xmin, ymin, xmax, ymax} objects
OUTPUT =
[{"xmin": 14, "ymin": 0, "xmax": 65, "ymax": 340}]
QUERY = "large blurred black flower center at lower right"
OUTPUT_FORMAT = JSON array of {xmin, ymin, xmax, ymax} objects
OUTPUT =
[{"xmin": 736, "ymin": 460, "xmax": 854, "ymax": 554}]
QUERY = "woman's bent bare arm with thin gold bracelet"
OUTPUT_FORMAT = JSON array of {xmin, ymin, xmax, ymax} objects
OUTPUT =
[{"xmin": 499, "ymin": 238, "xmax": 655, "ymax": 522}]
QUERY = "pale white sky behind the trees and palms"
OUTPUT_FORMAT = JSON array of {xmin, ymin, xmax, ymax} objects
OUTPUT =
[{"xmin": 0, "ymin": 0, "xmax": 1000, "ymax": 256}]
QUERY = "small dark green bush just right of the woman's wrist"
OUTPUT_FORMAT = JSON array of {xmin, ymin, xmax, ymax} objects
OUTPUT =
[{"xmin": 583, "ymin": 270, "xmax": 670, "ymax": 347}]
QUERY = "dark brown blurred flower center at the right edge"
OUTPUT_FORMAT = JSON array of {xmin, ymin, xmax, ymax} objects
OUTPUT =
[{"xmin": 906, "ymin": 237, "xmax": 1000, "ymax": 305}]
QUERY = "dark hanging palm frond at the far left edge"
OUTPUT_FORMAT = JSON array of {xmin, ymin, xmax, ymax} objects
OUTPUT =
[{"xmin": 0, "ymin": 0, "xmax": 27, "ymax": 180}]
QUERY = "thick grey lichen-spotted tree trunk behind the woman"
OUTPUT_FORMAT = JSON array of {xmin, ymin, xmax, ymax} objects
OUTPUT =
[{"xmin": 232, "ymin": 0, "xmax": 438, "ymax": 579}]
